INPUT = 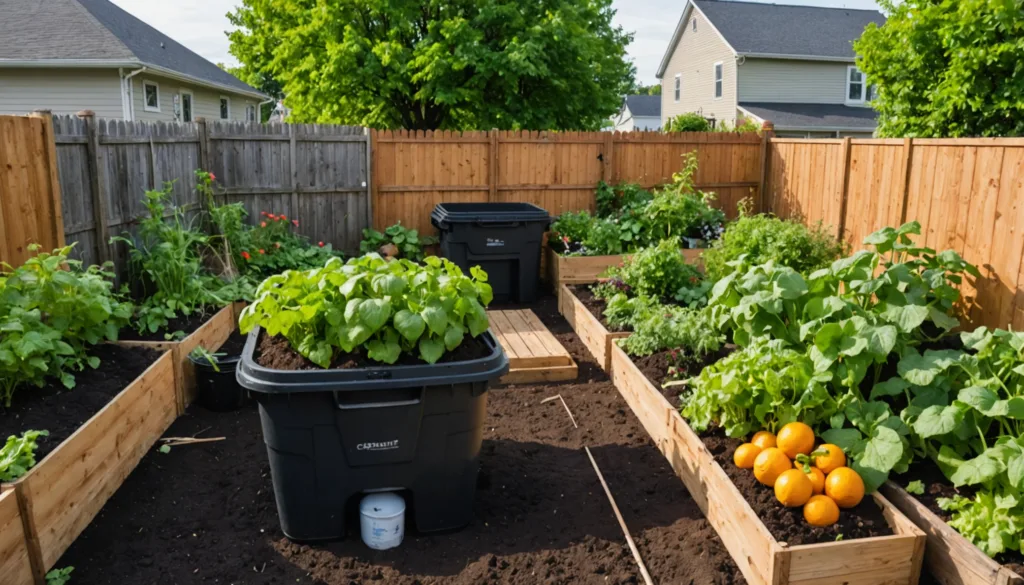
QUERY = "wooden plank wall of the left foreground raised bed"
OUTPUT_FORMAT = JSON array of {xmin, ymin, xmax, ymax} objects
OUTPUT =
[{"xmin": 0, "ymin": 351, "xmax": 177, "ymax": 584}]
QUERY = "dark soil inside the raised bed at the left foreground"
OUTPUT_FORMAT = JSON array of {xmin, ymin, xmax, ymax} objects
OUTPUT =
[{"xmin": 0, "ymin": 344, "xmax": 160, "ymax": 462}]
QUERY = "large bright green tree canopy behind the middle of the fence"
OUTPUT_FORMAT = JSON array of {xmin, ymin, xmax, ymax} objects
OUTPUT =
[{"xmin": 228, "ymin": 0, "xmax": 635, "ymax": 130}]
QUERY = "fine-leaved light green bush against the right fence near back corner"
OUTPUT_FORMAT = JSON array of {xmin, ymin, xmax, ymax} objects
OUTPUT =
[{"xmin": 702, "ymin": 210, "xmax": 843, "ymax": 280}]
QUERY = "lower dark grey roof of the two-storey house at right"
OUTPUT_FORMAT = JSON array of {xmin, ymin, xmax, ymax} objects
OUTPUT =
[{"xmin": 739, "ymin": 101, "xmax": 878, "ymax": 132}]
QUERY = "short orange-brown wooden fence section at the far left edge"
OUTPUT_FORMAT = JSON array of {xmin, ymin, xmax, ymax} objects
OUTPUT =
[{"xmin": 0, "ymin": 115, "xmax": 65, "ymax": 265}]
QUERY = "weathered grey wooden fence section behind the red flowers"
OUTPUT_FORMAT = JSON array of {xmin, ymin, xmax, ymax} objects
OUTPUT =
[{"xmin": 54, "ymin": 116, "xmax": 370, "ymax": 278}]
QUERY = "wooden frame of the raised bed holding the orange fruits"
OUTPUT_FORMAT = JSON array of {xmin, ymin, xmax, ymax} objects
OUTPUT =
[{"xmin": 611, "ymin": 346, "xmax": 925, "ymax": 585}]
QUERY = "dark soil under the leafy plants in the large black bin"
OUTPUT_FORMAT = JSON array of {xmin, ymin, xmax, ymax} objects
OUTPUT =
[{"xmin": 255, "ymin": 332, "xmax": 492, "ymax": 370}]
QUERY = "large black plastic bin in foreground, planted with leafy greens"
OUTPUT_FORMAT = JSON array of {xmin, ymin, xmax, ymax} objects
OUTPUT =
[{"xmin": 238, "ymin": 327, "xmax": 509, "ymax": 542}]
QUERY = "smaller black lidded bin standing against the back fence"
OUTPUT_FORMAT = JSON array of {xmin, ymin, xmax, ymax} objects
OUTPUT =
[{"xmin": 430, "ymin": 203, "xmax": 551, "ymax": 302}]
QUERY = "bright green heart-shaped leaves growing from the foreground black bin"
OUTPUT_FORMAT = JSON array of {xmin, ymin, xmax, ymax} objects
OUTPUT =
[{"xmin": 241, "ymin": 254, "xmax": 494, "ymax": 368}]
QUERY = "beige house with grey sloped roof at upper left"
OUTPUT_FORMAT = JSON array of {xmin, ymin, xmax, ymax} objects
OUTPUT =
[{"xmin": 0, "ymin": 0, "xmax": 269, "ymax": 122}]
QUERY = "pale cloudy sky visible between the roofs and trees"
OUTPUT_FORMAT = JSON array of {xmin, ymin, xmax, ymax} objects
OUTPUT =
[{"xmin": 113, "ymin": 0, "xmax": 878, "ymax": 84}]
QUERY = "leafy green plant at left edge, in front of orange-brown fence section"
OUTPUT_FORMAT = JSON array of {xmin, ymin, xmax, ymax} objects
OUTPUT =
[{"xmin": 0, "ymin": 246, "xmax": 132, "ymax": 407}]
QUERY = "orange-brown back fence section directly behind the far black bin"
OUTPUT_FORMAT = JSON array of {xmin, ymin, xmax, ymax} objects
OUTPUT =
[{"xmin": 371, "ymin": 130, "xmax": 766, "ymax": 234}]
